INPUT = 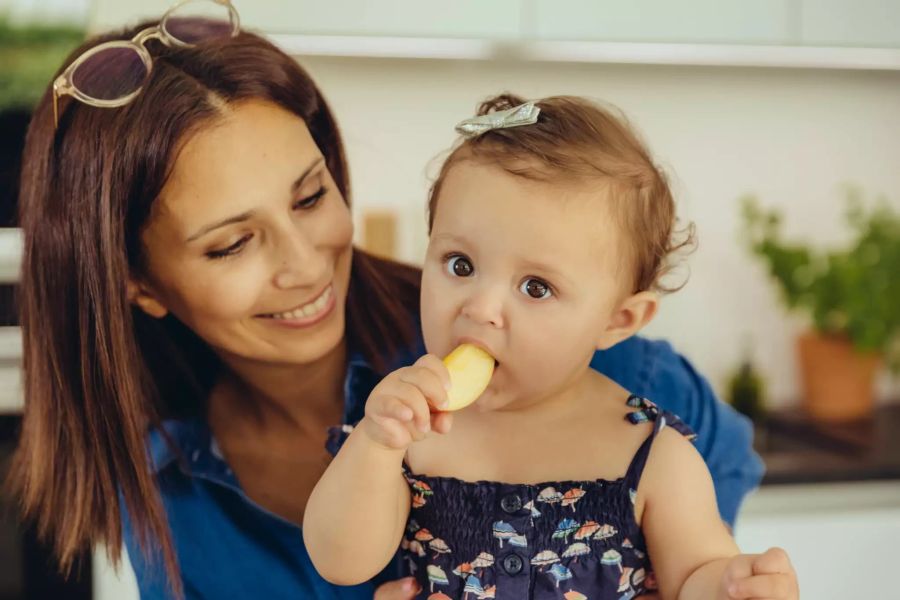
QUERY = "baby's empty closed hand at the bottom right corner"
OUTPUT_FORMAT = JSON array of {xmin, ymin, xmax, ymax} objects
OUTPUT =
[{"xmin": 722, "ymin": 548, "xmax": 800, "ymax": 600}]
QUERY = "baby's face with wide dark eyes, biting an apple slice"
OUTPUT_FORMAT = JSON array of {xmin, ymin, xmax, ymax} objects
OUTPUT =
[{"xmin": 422, "ymin": 160, "xmax": 630, "ymax": 410}]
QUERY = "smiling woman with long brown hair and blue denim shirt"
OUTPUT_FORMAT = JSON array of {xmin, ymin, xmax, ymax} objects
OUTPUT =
[{"xmin": 14, "ymin": 3, "xmax": 761, "ymax": 599}]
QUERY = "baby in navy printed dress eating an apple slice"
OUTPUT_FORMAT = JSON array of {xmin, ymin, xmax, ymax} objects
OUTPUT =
[{"xmin": 303, "ymin": 95, "xmax": 798, "ymax": 600}]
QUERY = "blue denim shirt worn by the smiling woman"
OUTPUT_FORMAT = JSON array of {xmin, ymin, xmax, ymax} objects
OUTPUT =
[{"xmin": 124, "ymin": 337, "xmax": 763, "ymax": 600}]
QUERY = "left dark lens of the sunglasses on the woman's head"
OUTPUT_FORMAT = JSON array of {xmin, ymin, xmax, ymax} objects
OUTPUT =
[{"xmin": 72, "ymin": 47, "xmax": 149, "ymax": 100}]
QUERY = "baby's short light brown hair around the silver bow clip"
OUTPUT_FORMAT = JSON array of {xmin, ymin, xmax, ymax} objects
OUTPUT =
[{"xmin": 428, "ymin": 93, "xmax": 696, "ymax": 293}]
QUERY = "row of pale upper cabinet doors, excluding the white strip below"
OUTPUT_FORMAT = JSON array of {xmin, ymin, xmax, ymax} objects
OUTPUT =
[{"xmin": 88, "ymin": 0, "xmax": 900, "ymax": 48}]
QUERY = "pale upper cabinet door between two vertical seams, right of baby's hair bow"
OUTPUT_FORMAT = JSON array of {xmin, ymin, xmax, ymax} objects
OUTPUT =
[{"xmin": 526, "ymin": 0, "xmax": 794, "ymax": 44}]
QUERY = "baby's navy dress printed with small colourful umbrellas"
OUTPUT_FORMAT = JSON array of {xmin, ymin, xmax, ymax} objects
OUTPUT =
[{"xmin": 401, "ymin": 396, "xmax": 694, "ymax": 600}]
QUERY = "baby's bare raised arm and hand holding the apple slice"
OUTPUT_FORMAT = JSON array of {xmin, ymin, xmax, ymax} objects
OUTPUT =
[{"xmin": 303, "ymin": 355, "xmax": 451, "ymax": 585}]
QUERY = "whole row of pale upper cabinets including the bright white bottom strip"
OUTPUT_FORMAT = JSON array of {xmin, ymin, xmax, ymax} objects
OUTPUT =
[{"xmin": 88, "ymin": 0, "xmax": 900, "ymax": 70}]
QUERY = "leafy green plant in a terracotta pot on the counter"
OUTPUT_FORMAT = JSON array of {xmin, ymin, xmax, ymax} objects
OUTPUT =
[{"xmin": 742, "ymin": 188, "xmax": 900, "ymax": 421}]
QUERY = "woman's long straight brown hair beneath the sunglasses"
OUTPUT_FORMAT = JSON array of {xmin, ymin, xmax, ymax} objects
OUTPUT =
[{"xmin": 11, "ymin": 24, "xmax": 418, "ymax": 596}]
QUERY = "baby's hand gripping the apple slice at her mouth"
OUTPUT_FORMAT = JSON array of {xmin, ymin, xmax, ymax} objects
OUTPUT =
[{"xmin": 360, "ymin": 354, "xmax": 452, "ymax": 450}]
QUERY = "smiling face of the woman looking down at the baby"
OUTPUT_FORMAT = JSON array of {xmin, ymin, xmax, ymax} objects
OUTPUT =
[{"xmin": 129, "ymin": 101, "xmax": 353, "ymax": 365}]
